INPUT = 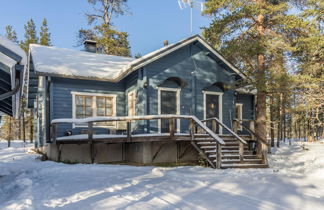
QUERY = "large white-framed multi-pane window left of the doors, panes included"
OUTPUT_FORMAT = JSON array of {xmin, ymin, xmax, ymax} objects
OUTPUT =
[{"xmin": 72, "ymin": 92, "xmax": 116, "ymax": 126}]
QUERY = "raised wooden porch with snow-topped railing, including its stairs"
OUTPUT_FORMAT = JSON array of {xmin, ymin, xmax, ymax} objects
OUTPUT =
[{"xmin": 48, "ymin": 115, "xmax": 268, "ymax": 168}]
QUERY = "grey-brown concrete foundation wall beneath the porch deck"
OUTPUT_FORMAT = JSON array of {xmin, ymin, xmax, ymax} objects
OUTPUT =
[{"xmin": 44, "ymin": 141, "xmax": 198, "ymax": 165}]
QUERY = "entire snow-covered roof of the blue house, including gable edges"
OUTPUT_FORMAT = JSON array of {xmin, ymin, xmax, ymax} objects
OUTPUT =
[{"xmin": 30, "ymin": 35, "xmax": 245, "ymax": 82}]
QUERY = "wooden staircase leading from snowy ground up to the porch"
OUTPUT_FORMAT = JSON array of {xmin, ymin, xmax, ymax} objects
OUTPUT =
[{"xmin": 193, "ymin": 134, "xmax": 268, "ymax": 169}]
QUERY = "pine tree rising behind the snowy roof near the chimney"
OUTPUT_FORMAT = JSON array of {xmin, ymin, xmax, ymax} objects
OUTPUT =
[{"xmin": 78, "ymin": 0, "xmax": 130, "ymax": 56}]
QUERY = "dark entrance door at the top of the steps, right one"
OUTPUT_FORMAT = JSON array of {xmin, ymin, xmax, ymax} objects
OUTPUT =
[{"xmin": 205, "ymin": 93, "xmax": 221, "ymax": 133}]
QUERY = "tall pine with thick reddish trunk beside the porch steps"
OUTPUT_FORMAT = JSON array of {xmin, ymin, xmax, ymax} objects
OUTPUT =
[{"xmin": 204, "ymin": 0, "xmax": 308, "ymax": 149}]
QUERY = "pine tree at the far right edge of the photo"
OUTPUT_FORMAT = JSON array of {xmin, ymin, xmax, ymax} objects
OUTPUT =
[{"xmin": 294, "ymin": 0, "xmax": 324, "ymax": 139}]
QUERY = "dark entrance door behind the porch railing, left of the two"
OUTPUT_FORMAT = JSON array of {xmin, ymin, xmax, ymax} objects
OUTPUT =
[{"xmin": 159, "ymin": 90, "xmax": 178, "ymax": 133}]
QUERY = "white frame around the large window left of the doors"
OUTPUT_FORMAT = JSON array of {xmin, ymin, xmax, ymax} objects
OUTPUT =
[{"xmin": 71, "ymin": 91, "xmax": 117, "ymax": 128}]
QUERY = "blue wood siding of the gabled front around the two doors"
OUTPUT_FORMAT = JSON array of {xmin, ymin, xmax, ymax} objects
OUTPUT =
[{"xmin": 135, "ymin": 45, "xmax": 235, "ymax": 132}]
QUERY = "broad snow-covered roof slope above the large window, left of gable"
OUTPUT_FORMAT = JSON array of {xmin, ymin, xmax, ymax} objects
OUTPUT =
[{"xmin": 30, "ymin": 44, "xmax": 134, "ymax": 81}]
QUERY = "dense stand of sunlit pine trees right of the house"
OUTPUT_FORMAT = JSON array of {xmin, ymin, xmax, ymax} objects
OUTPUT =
[{"xmin": 203, "ymin": 0, "xmax": 324, "ymax": 143}]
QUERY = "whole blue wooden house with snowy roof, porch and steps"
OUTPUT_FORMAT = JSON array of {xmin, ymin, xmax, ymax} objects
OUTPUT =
[{"xmin": 28, "ymin": 35, "xmax": 267, "ymax": 168}]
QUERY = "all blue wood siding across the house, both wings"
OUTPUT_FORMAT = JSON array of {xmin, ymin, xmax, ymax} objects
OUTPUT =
[{"xmin": 40, "ymin": 43, "xmax": 254, "ymax": 141}]
